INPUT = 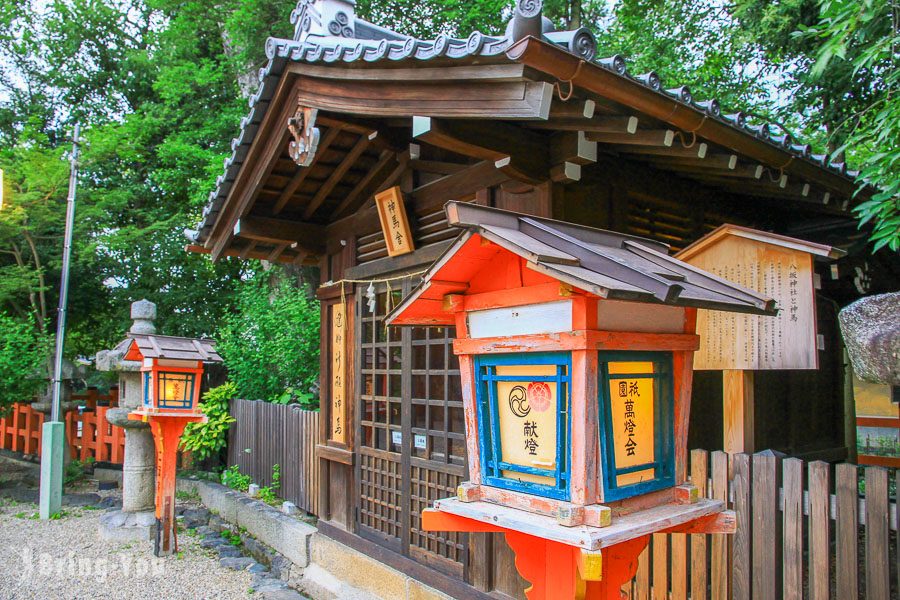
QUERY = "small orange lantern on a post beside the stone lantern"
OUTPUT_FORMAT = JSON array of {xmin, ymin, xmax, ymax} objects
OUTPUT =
[{"xmin": 125, "ymin": 333, "xmax": 222, "ymax": 556}]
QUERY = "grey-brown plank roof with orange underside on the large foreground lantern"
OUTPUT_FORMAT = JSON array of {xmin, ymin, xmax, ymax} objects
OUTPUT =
[{"xmin": 387, "ymin": 202, "xmax": 777, "ymax": 325}]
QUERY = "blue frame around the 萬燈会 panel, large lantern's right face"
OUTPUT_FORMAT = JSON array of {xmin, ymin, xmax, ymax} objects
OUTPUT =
[{"xmin": 598, "ymin": 352, "xmax": 675, "ymax": 502}]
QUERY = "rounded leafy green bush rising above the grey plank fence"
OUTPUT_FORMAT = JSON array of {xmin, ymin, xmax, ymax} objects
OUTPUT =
[{"xmin": 217, "ymin": 269, "xmax": 319, "ymax": 403}]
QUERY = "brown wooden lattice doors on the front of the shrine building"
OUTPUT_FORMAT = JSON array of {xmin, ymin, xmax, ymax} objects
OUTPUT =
[{"xmin": 357, "ymin": 282, "xmax": 468, "ymax": 577}]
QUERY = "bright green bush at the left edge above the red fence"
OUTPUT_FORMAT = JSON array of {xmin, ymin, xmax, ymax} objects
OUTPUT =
[{"xmin": 0, "ymin": 314, "xmax": 49, "ymax": 412}]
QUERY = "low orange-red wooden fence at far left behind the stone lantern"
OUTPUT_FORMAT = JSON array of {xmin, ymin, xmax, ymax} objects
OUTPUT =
[{"xmin": 0, "ymin": 388, "xmax": 125, "ymax": 464}]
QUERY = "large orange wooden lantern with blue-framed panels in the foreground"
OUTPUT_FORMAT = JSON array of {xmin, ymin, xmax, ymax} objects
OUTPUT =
[{"xmin": 387, "ymin": 202, "xmax": 775, "ymax": 600}]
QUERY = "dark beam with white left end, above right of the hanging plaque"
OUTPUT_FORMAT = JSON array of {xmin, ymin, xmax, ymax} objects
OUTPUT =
[{"xmin": 413, "ymin": 117, "xmax": 550, "ymax": 183}]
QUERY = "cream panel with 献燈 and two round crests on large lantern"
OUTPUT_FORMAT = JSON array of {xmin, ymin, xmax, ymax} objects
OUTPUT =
[{"xmin": 497, "ymin": 365, "xmax": 558, "ymax": 485}]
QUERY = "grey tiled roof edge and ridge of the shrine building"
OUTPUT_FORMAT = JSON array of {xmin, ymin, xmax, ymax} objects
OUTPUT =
[{"xmin": 185, "ymin": 0, "xmax": 857, "ymax": 243}]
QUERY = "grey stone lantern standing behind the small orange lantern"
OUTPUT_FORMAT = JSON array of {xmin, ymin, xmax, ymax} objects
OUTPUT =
[{"xmin": 97, "ymin": 300, "xmax": 156, "ymax": 541}]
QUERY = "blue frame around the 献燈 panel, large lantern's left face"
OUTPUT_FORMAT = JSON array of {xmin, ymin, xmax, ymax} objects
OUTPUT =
[{"xmin": 475, "ymin": 352, "xmax": 572, "ymax": 500}]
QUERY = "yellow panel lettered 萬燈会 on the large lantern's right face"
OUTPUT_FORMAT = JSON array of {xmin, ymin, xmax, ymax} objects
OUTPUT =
[{"xmin": 608, "ymin": 362, "xmax": 656, "ymax": 486}]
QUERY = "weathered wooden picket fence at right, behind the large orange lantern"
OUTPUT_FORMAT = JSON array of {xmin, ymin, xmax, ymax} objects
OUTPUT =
[{"xmin": 623, "ymin": 450, "xmax": 900, "ymax": 600}]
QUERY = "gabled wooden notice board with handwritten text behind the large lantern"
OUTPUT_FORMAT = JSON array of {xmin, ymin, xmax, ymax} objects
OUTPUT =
[{"xmin": 677, "ymin": 225, "xmax": 840, "ymax": 370}]
